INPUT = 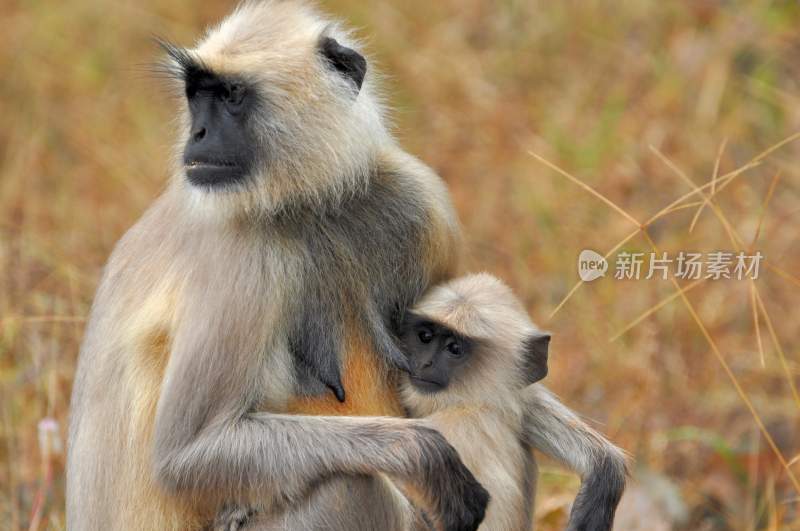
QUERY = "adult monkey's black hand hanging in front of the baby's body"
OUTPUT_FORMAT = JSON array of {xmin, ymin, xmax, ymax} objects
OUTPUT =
[{"xmin": 418, "ymin": 427, "xmax": 489, "ymax": 531}]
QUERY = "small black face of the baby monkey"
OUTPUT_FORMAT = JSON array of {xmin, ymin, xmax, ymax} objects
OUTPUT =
[{"xmin": 401, "ymin": 316, "xmax": 475, "ymax": 393}]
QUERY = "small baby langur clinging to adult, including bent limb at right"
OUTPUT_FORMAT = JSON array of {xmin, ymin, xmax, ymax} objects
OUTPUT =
[{"xmin": 399, "ymin": 273, "xmax": 626, "ymax": 531}]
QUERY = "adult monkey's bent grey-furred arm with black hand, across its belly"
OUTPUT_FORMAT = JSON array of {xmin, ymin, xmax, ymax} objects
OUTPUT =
[{"xmin": 153, "ymin": 317, "xmax": 488, "ymax": 530}]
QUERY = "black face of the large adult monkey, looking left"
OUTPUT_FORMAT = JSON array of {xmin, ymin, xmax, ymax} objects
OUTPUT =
[{"xmin": 183, "ymin": 70, "xmax": 255, "ymax": 187}]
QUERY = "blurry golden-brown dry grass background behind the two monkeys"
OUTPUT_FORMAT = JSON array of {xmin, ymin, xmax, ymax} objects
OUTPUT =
[{"xmin": 0, "ymin": 0, "xmax": 800, "ymax": 530}]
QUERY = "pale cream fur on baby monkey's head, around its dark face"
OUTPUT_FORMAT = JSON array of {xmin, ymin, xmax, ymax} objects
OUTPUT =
[{"xmin": 403, "ymin": 273, "xmax": 550, "ymax": 416}]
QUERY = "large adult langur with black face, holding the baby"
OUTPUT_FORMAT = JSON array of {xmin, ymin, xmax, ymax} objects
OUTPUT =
[{"xmin": 67, "ymin": 0, "xmax": 488, "ymax": 531}]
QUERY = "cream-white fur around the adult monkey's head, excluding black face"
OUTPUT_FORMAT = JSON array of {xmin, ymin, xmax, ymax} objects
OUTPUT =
[{"xmin": 175, "ymin": 0, "xmax": 392, "ymax": 220}]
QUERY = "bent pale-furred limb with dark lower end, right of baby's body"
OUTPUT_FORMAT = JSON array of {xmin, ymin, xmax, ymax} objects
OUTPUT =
[{"xmin": 522, "ymin": 384, "xmax": 627, "ymax": 531}]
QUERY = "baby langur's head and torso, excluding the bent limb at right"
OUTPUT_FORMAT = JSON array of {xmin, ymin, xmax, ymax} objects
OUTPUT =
[{"xmin": 400, "ymin": 274, "xmax": 550, "ymax": 531}]
